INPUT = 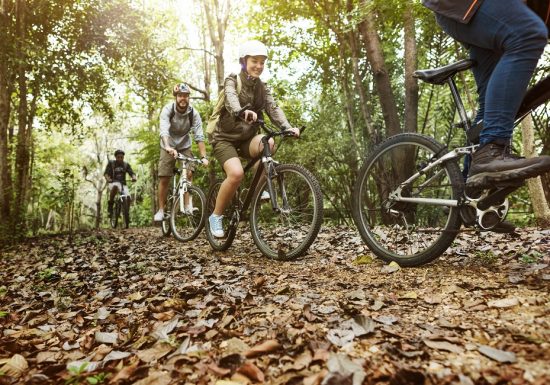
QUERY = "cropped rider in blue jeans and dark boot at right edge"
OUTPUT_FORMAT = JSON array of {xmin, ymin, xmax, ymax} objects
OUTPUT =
[{"xmin": 422, "ymin": 0, "xmax": 550, "ymax": 188}]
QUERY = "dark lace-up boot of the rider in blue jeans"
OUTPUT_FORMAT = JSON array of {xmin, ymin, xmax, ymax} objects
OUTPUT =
[{"xmin": 466, "ymin": 142, "xmax": 550, "ymax": 188}]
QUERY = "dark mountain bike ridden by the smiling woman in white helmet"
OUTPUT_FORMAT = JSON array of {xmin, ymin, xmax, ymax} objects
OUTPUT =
[{"xmin": 206, "ymin": 120, "xmax": 323, "ymax": 260}]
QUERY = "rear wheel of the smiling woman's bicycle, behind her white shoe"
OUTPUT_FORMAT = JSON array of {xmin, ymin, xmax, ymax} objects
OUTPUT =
[{"xmin": 205, "ymin": 181, "xmax": 239, "ymax": 251}]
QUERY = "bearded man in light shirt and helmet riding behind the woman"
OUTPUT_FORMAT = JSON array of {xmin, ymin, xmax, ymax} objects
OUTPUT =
[{"xmin": 154, "ymin": 83, "xmax": 208, "ymax": 222}]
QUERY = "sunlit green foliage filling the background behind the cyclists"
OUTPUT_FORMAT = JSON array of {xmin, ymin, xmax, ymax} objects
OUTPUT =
[{"xmin": 0, "ymin": 0, "xmax": 550, "ymax": 234}]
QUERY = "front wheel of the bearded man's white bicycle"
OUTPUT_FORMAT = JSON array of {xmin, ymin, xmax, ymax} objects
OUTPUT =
[{"xmin": 170, "ymin": 186, "xmax": 206, "ymax": 242}]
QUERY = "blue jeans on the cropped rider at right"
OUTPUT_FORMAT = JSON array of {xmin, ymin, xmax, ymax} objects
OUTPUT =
[{"xmin": 438, "ymin": 0, "xmax": 547, "ymax": 144}]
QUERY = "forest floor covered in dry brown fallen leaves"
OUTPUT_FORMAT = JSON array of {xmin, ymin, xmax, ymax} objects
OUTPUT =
[{"xmin": 0, "ymin": 226, "xmax": 550, "ymax": 385}]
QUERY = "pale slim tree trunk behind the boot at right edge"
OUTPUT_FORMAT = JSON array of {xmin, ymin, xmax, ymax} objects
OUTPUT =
[{"xmin": 521, "ymin": 115, "xmax": 550, "ymax": 227}]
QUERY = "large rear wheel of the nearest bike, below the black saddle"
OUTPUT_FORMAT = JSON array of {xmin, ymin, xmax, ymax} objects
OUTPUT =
[{"xmin": 352, "ymin": 133, "xmax": 464, "ymax": 266}]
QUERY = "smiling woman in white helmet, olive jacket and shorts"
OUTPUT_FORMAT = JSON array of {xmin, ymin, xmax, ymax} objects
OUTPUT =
[{"xmin": 208, "ymin": 40, "xmax": 300, "ymax": 238}]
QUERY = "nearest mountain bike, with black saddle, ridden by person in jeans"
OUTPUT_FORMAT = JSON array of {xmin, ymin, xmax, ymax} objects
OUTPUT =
[{"xmin": 352, "ymin": 60, "xmax": 550, "ymax": 266}]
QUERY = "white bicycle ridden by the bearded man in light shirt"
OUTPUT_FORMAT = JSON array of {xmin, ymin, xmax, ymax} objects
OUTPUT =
[{"xmin": 161, "ymin": 154, "xmax": 206, "ymax": 242}]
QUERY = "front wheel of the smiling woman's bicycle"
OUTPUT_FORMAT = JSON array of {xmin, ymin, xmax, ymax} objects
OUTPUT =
[{"xmin": 250, "ymin": 164, "xmax": 323, "ymax": 260}]
